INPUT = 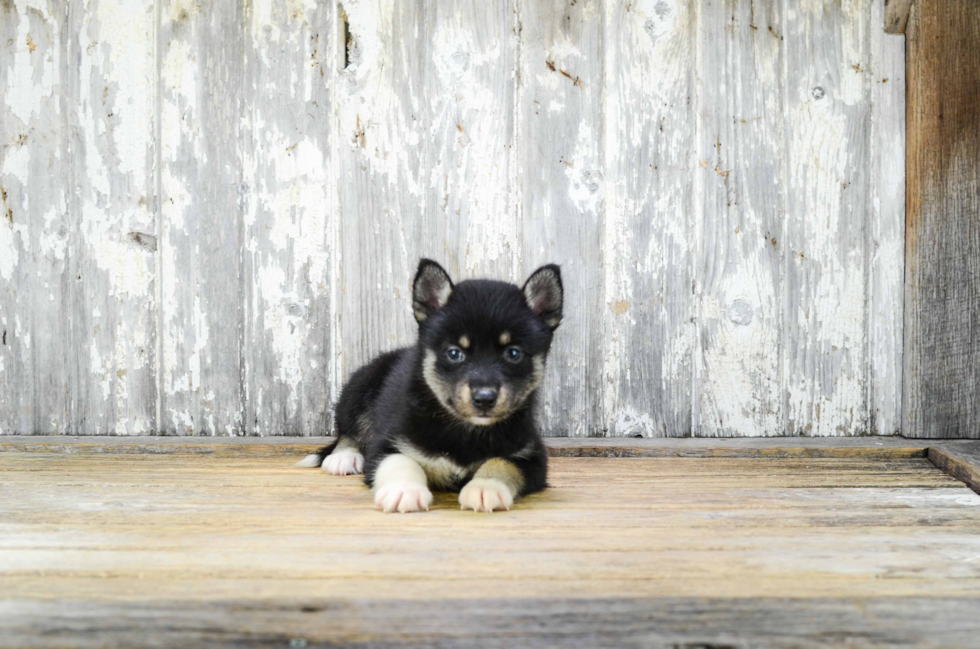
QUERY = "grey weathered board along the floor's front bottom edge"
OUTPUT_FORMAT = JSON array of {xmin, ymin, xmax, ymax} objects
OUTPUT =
[{"xmin": 0, "ymin": 596, "xmax": 980, "ymax": 649}]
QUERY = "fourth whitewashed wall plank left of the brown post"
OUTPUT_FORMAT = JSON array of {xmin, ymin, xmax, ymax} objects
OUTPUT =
[{"xmin": 600, "ymin": 0, "xmax": 697, "ymax": 436}]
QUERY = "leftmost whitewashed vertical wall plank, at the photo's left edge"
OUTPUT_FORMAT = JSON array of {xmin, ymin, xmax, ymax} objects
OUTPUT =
[{"xmin": 0, "ymin": 0, "xmax": 74, "ymax": 435}]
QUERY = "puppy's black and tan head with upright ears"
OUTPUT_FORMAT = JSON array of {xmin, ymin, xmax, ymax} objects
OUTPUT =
[{"xmin": 412, "ymin": 259, "xmax": 563, "ymax": 426}]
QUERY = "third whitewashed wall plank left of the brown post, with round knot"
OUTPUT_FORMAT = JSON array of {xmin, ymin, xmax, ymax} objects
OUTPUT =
[{"xmin": 694, "ymin": 0, "xmax": 784, "ymax": 437}]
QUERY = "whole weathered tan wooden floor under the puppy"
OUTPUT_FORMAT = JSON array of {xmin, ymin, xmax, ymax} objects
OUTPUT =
[{"xmin": 0, "ymin": 438, "xmax": 980, "ymax": 647}]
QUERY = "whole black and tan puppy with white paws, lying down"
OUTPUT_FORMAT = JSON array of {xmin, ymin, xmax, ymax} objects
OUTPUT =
[{"xmin": 299, "ymin": 259, "xmax": 563, "ymax": 512}]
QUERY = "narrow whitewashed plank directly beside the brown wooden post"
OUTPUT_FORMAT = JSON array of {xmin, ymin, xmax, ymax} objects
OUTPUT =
[{"xmin": 867, "ymin": 2, "xmax": 905, "ymax": 435}]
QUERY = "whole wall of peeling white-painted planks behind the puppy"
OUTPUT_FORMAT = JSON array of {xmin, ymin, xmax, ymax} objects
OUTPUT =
[{"xmin": 0, "ymin": 0, "xmax": 905, "ymax": 436}]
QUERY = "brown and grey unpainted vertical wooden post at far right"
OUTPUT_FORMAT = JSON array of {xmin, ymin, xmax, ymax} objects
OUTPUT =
[{"xmin": 903, "ymin": 1, "xmax": 980, "ymax": 438}]
